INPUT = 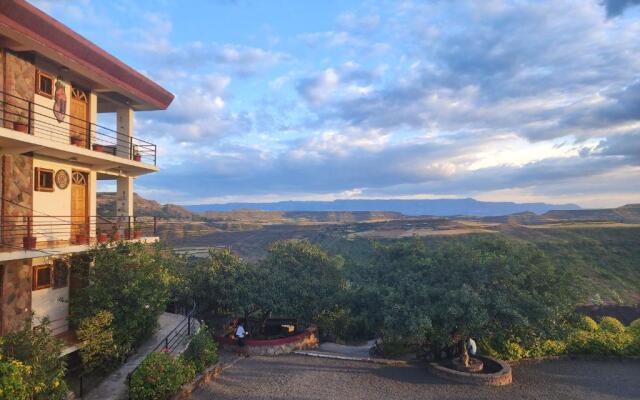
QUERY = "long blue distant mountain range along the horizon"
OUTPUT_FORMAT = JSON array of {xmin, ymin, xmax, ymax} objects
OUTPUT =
[{"xmin": 184, "ymin": 199, "xmax": 581, "ymax": 217}]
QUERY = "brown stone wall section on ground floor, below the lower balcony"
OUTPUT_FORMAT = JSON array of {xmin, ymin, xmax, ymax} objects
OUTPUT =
[{"xmin": 0, "ymin": 260, "xmax": 31, "ymax": 335}]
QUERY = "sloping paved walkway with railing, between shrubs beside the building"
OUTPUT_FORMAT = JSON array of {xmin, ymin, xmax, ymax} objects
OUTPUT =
[{"xmin": 83, "ymin": 313, "xmax": 185, "ymax": 400}]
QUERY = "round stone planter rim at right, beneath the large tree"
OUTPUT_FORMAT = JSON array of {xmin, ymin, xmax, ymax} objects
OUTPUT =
[{"xmin": 428, "ymin": 356, "xmax": 512, "ymax": 386}]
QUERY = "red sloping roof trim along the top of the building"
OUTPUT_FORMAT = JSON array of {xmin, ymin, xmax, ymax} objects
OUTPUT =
[{"xmin": 0, "ymin": 0, "xmax": 174, "ymax": 109}]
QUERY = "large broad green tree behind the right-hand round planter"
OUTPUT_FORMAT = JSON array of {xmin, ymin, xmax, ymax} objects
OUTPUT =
[{"xmin": 362, "ymin": 238, "xmax": 575, "ymax": 361}]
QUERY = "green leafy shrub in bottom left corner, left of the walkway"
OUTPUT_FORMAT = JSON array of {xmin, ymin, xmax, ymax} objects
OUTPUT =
[{"xmin": 2, "ymin": 321, "xmax": 67, "ymax": 400}]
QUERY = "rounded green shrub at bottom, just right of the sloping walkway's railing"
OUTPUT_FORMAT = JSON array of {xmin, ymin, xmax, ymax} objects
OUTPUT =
[{"xmin": 129, "ymin": 353, "xmax": 195, "ymax": 400}]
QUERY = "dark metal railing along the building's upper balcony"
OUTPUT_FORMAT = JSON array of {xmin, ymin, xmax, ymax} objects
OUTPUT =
[{"xmin": 0, "ymin": 91, "xmax": 156, "ymax": 165}]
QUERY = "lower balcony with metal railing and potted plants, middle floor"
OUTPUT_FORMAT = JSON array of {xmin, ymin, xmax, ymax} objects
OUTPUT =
[{"xmin": 0, "ymin": 215, "xmax": 158, "ymax": 262}]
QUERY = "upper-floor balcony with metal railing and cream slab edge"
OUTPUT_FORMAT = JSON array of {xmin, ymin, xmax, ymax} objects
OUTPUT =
[{"xmin": 0, "ymin": 91, "xmax": 158, "ymax": 176}]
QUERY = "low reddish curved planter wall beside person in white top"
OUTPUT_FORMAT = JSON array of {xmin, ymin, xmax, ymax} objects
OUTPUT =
[{"xmin": 215, "ymin": 326, "xmax": 319, "ymax": 356}]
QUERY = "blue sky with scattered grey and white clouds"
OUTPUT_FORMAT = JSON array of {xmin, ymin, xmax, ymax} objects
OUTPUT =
[{"xmin": 33, "ymin": 0, "xmax": 640, "ymax": 207}]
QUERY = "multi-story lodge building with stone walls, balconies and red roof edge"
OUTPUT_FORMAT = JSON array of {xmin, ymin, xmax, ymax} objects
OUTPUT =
[{"xmin": 0, "ymin": 0, "xmax": 173, "ymax": 350}]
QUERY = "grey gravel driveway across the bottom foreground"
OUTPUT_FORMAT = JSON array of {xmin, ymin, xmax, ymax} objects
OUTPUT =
[{"xmin": 193, "ymin": 355, "xmax": 640, "ymax": 400}]
